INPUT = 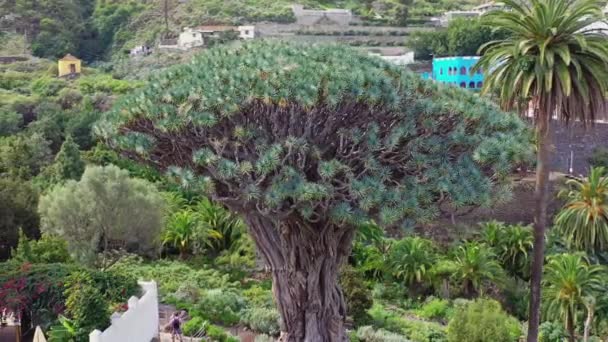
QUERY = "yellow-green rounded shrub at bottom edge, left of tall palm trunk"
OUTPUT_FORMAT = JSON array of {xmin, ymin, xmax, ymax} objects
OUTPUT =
[{"xmin": 448, "ymin": 299, "xmax": 521, "ymax": 342}]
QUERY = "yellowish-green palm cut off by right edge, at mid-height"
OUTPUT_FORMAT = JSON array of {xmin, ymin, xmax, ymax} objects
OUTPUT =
[{"xmin": 555, "ymin": 167, "xmax": 608, "ymax": 251}]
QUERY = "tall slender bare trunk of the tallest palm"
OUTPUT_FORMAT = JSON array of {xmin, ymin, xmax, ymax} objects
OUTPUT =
[{"xmin": 528, "ymin": 115, "xmax": 551, "ymax": 342}]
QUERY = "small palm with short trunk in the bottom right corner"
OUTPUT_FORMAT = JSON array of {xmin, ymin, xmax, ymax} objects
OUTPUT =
[{"xmin": 543, "ymin": 254, "xmax": 606, "ymax": 342}]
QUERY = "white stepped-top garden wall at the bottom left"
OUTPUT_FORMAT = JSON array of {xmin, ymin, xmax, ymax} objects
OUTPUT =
[{"xmin": 89, "ymin": 281, "xmax": 158, "ymax": 342}]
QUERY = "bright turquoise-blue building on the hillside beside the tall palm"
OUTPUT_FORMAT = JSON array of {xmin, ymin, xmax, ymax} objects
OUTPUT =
[{"xmin": 422, "ymin": 56, "xmax": 483, "ymax": 90}]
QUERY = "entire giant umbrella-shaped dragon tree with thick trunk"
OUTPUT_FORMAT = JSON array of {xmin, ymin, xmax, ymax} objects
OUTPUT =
[{"xmin": 95, "ymin": 42, "xmax": 528, "ymax": 341}]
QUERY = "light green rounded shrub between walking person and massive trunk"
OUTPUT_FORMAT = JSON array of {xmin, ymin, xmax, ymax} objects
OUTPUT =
[{"xmin": 198, "ymin": 289, "xmax": 245, "ymax": 325}]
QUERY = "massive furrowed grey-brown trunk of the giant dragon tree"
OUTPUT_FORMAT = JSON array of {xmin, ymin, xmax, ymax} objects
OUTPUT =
[{"xmin": 246, "ymin": 215, "xmax": 354, "ymax": 342}]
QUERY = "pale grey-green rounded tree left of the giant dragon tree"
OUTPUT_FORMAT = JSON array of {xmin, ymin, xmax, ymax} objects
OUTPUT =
[{"xmin": 38, "ymin": 166, "xmax": 164, "ymax": 261}]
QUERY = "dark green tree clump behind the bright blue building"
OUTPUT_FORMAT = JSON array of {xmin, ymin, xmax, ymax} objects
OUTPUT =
[{"xmin": 406, "ymin": 19, "xmax": 507, "ymax": 60}]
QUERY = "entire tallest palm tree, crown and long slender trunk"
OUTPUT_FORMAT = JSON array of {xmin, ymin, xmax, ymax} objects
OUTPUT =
[{"xmin": 473, "ymin": 0, "xmax": 608, "ymax": 336}]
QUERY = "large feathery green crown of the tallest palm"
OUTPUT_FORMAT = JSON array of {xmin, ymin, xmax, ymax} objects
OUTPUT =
[{"xmin": 476, "ymin": 0, "xmax": 608, "ymax": 121}]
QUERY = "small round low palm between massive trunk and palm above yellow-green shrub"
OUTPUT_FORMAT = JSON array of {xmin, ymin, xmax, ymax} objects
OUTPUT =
[{"xmin": 388, "ymin": 236, "xmax": 437, "ymax": 289}]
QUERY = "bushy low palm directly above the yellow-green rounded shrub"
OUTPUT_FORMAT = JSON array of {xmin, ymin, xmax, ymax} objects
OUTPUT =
[{"xmin": 452, "ymin": 242, "xmax": 504, "ymax": 297}]
